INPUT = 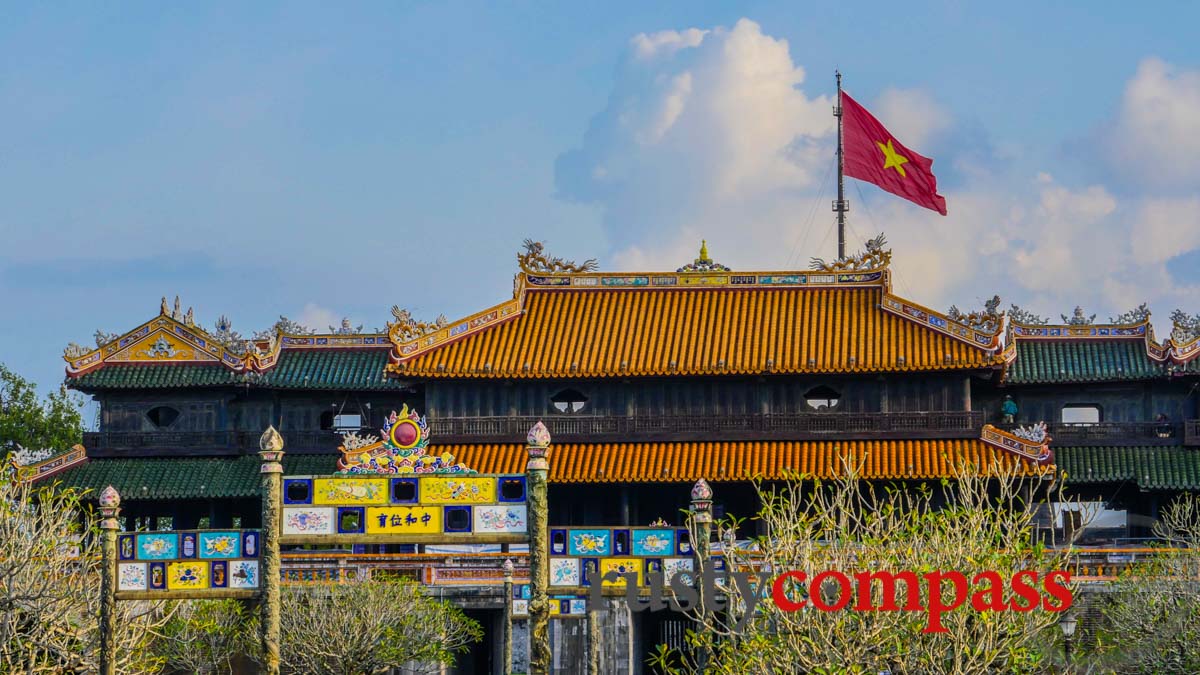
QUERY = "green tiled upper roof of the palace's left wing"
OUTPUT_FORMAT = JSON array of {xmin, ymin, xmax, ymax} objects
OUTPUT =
[{"xmin": 67, "ymin": 348, "xmax": 406, "ymax": 392}]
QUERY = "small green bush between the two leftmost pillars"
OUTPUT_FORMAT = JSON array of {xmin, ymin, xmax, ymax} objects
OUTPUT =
[{"xmin": 155, "ymin": 599, "xmax": 257, "ymax": 675}]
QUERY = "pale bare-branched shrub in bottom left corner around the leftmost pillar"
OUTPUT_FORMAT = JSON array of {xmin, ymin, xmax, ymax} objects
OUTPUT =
[{"xmin": 0, "ymin": 471, "xmax": 168, "ymax": 674}]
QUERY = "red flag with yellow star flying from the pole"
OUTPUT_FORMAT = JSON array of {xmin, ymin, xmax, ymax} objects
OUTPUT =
[{"xmin": 841, "ymin": 91, "xmax": 946, "ymax": 216}]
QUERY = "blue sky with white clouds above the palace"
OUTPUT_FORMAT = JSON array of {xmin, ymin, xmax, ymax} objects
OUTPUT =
[{"xmin": 0, "ymin": 1, "xmax": 1200, "ymax": 401}]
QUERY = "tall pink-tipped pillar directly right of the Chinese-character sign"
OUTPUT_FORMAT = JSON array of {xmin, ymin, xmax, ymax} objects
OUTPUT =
[{"xmin": 526, "ymin": 422, "xmax": 552, "ymax": 675}]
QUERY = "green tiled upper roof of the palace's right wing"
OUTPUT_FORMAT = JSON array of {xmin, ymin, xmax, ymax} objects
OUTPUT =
[{"xmin": 1007, "ymin": 339, "xmax": 1163, "ymax": 384}]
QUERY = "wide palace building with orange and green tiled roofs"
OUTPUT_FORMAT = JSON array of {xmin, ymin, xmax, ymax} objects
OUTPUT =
[{"xmin": 22, "ymin": 238, "xmax": 1200, "ymax": 658}]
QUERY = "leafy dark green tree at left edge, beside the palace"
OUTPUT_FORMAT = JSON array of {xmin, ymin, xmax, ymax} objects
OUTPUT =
[{"xmin": 0, "ymin": 364, "xmax": 83, "ymax": 459}]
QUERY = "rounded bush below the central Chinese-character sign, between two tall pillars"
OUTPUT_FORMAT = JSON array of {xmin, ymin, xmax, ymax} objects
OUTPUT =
[{"xmin": 281, "ymin": 571, "xmax": 484, "ymax": 675}]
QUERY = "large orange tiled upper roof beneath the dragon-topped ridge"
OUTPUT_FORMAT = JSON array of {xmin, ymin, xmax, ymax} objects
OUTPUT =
[{"xmin": 397, "ymin": 287, "xmax": 996, "ymax": 377}]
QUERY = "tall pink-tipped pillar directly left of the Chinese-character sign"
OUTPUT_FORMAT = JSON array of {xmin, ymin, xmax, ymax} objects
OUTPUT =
[{"xmin": 258, "ymin": 426, "xmax": 283, "ymax": 675}]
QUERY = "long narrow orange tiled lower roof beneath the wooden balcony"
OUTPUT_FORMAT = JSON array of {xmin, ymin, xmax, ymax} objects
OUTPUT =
[{"xmin": 436, "ymin": 438, "xmax": 1038, "ymax": 483}]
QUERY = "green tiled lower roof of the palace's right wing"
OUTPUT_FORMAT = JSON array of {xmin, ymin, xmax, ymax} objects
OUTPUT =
[{"xmin": 1055, "ymin": 447, "xmax": 1200, "ymax": 490}]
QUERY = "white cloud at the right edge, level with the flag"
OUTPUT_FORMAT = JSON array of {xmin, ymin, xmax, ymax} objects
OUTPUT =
[{"xmin": 1093, "ymin": 58, "xmax": 1200, "ymax": 189}]
